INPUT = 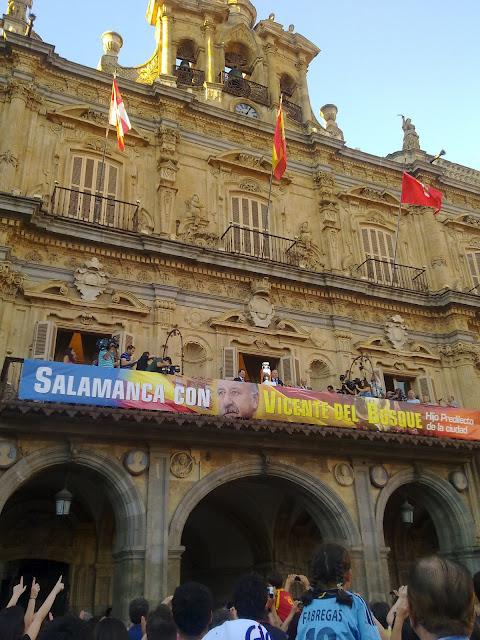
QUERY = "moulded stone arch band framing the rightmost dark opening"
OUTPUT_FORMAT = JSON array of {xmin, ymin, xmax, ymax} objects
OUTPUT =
[{"xmin": 375, "ymin": 469, "xmax": 476, "ymax": 554}]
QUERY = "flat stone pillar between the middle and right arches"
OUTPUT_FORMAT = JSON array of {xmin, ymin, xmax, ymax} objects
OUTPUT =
[{"xmin": 354, "ymin": 462, "xmax": 388, "ymax": 602}]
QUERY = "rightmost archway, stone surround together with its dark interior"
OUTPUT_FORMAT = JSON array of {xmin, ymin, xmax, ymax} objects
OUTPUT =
[{"xmin": 376, "ymin": 469, "xmax": 476, "ymax": 587}]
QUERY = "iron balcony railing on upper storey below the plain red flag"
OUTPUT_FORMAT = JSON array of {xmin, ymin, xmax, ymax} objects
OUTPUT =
[{"xmin": 357, "ymin": 258, "xmax": 428, "ymax": 293}]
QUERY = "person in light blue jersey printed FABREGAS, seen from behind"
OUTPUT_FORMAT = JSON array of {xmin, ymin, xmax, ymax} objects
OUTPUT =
[{"xmin": 297, "ymin": 543, "xmax": 380, "ymax": 640}]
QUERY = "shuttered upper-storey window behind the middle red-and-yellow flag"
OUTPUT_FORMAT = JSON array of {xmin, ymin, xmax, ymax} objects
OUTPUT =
[{"xmin": 232, "ymin": 196, "xmax": 271, "ymax": 258}]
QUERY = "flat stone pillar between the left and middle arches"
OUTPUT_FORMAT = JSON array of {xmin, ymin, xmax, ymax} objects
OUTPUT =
[{"xmin": 144, "ymin": 447, "xmax": 170, "ymax": 605}]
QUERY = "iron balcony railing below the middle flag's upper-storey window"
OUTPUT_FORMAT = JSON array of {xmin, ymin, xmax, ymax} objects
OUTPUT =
[{"xmin": 221, "ymin": 224, "xmax": 298, "ymax": 266}]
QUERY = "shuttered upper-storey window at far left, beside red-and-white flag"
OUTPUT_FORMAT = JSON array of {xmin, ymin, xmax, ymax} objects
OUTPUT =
[{"xmin": 68, "ymin": 155, "xmax": 119, "ymax": 226}]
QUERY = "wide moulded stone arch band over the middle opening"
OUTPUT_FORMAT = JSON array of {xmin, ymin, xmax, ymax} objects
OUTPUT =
[{"xmin": 169, "ymin": 460, "xmax": 361, "ymax": 549}]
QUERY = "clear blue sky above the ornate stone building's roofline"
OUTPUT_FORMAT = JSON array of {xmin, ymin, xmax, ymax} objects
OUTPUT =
[{"xmin": 32, "ymin": 0, "xmax": 480, "ymax": 169}]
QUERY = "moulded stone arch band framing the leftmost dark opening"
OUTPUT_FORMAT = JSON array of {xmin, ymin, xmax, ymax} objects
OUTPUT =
[{"xmin": 0, "ymin": 446, "xmax": 146, "ymax": 552}]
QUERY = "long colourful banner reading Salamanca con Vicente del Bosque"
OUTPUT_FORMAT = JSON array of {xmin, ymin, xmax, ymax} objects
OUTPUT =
[{"xmin": 19, "ymin": 360, "xmax": 480, "ymax": 440}]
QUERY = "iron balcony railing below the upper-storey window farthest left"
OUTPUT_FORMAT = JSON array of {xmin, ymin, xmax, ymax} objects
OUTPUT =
[{"xmin": 51, "ymin": 185, "xmax": 140, "ymax": 232}]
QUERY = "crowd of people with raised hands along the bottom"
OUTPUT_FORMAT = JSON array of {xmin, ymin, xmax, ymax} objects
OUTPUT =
[{"xmin": 0, "ymin": 543, "xmax": 480, "ymax": 640}]
